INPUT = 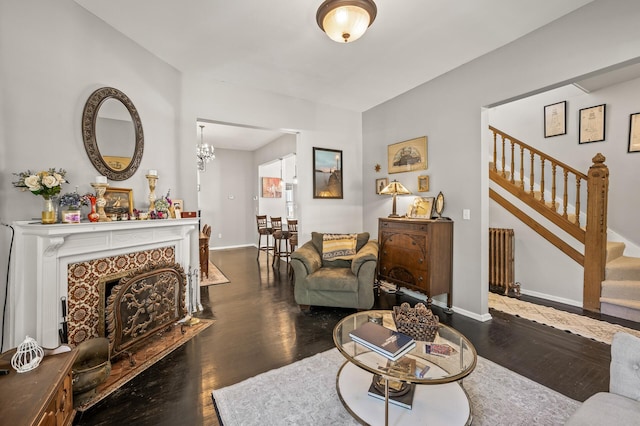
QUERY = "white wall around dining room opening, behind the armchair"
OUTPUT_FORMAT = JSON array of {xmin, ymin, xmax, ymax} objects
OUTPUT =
[{"xmin": 180, "ymin": 74, "xmax": 363, "ymax": 246}]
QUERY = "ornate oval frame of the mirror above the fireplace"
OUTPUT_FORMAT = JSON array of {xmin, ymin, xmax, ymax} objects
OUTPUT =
[{"xmin": 82, "ymin": 87, "xmax": 144, "ymax": 180}]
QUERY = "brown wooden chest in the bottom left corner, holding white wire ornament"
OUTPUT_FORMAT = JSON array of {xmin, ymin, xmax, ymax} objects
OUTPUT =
[{"xmin": 0, "ymin": 349, "xmax": 78, "ymax": 426}]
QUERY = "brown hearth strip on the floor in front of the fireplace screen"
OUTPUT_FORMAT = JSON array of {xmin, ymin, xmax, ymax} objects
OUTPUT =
[{"xmin": 76, "ymin": 319, "xmax": 215, "ymax": 411}]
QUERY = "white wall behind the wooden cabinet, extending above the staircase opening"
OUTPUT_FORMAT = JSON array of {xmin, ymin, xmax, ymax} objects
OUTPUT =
[{"xmin": 363, "ymin": 0, "xmax": 640, "ymax": 318}]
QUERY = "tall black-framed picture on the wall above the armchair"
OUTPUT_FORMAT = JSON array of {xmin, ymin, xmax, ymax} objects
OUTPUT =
[{"xmin": 313, "ymin": 147, "xmax": 343, "ymax": 198}]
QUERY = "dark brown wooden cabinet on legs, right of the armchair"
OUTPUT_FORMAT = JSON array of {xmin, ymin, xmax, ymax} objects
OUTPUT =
[{"xmin": 378, "ymin": 218, "xmax": 453, "ymax": 309}]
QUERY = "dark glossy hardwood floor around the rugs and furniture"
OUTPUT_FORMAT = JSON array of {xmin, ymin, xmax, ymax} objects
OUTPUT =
[{"xmin": 74, "ymin": 248, "xmax": 620, "ymax": 426}]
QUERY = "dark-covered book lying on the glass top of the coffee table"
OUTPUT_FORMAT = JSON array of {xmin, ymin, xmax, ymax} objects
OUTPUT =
[{"xmin": 349, "ymin": 322, "xmax": 416, "ymax": 361}]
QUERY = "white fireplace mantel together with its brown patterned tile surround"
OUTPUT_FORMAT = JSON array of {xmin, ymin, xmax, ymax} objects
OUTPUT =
[{"xmin": 2, "ymin": 219, "xmax": 202, "ymax": 351}]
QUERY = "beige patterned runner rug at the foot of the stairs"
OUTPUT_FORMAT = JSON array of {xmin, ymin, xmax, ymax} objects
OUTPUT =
[{"xmin": 489, "ymin": 292, "xmax": 640, "ymax": 345}]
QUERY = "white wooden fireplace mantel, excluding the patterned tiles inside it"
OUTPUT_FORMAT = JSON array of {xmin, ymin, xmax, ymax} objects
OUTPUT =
[{"xmin": 2, "ymin": 219, "xmax": 200, "ymax": 350}]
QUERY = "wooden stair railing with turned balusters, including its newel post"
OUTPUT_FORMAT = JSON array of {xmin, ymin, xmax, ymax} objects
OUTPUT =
[{"xmin": 489, "ymin": 126, "xmax": 608, "ymax": 312}]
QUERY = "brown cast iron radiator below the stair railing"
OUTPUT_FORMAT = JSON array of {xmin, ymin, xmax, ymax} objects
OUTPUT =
[{"xmin": 489, "ymin": 228, "xmax": 519, "ymax": 294}]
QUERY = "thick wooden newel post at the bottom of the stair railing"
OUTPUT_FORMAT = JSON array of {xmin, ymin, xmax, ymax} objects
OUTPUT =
[{"xmin": 582, "ymin": 153, "xmax": 609, "ymax": 312}]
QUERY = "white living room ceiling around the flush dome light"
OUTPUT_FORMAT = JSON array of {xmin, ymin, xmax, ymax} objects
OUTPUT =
[{"xmin": 75, "ymin": 0, "xmax": 592, "ymax": 146}]
